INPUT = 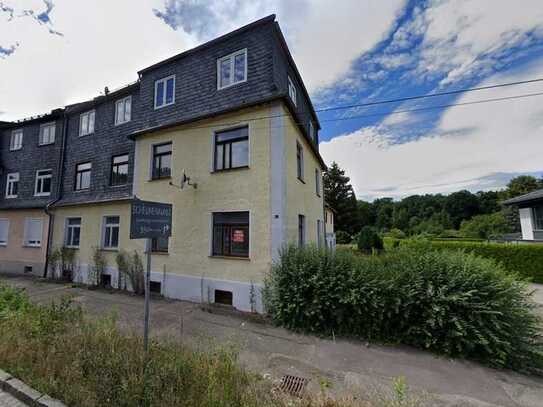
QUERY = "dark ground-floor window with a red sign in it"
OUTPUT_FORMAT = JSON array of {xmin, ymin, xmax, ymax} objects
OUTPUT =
[{"xmin": 212, "ymin": 212, "xmax": 249, "ymax": 257}]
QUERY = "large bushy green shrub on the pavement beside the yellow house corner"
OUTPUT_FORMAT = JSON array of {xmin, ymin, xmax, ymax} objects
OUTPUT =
[{"xmin": 264, "ymin": 247, "xmax": 543, "ymax": 370}]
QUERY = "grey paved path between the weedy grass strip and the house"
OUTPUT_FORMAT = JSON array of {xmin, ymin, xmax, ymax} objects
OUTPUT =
[{"xmin": 0, "ymin": 276, "xmax": 543, "ymax": 407}]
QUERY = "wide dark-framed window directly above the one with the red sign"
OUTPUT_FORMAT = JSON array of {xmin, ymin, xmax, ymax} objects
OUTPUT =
[{"xmin": 214, "ymin": 127, "xmax": 249, "ymax": 171}]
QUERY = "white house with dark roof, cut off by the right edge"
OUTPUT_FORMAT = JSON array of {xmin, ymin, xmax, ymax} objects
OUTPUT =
[{"xmin": 504, "ymin": 189, "xmax": 543, "ymax": 241}]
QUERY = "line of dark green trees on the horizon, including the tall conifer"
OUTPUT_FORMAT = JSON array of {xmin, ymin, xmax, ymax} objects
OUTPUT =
[{"xmin": 323, "ymin": 162, "xmax": 543, "ymax": 243}]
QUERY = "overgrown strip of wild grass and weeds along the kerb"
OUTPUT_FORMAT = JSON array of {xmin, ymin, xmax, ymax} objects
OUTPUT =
[{"xmin": 0, "ymin": 285, "xmax": 418, "ymax": 407}]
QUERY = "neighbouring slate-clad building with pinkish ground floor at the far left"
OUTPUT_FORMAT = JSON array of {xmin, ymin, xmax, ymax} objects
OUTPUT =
[{"xmin": 0, "ymin": 109, "xmax": 64, "ymax": 275}]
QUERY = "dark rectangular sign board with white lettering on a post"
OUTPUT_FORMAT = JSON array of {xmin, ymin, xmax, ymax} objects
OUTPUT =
[{"xmin": 130, "ymin": 199, "xmax": 172, "ymax": 239}]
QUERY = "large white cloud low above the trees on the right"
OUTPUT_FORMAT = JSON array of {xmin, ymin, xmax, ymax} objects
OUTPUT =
[{"xmin": 320, "ymin": 59, "xmax": 543, "ymax": 202}]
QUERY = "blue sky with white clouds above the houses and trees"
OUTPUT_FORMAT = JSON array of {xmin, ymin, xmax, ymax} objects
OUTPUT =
[{"xmin": 0, "ymin": 0, "xmax": 543, "ymax": 200}]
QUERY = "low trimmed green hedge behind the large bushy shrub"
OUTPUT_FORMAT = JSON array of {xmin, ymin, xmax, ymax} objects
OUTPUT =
[{"xmin": 385, "ymin": 238, "xmax": 543, "ymax": 284}]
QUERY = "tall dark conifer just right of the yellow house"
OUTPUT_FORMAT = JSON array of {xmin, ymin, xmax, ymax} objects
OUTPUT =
[{"xmin": 323, "ymin": 162, "xmax": 360, "ymax": 235}]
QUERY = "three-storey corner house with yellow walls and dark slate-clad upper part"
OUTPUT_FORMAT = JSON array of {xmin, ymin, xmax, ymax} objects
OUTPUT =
[{"xmin": 0, "ymin": 15, "xmax": 325, "ymax": 311}]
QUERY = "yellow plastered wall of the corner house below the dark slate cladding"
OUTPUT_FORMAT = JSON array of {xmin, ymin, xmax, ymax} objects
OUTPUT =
[{"xmin": 49, "ymin": 102, "xmax": 324, "ymax": 309}]
